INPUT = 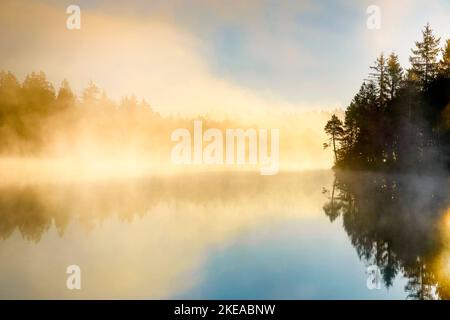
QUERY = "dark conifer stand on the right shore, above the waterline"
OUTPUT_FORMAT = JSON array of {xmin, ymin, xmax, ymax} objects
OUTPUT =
[{"xmin": 324, "ymin": 24, "xmax": 450, "ymax": 171}]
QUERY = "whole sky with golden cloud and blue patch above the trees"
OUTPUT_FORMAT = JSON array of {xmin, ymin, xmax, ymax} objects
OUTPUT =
[{"xmin": 0, "ymin": 0, "xmax": 450, "ymax": 118}]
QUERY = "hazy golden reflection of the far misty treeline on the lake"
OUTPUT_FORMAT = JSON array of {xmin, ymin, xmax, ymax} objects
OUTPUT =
[{"xmin": 0, "ymin": 171, "xmax": 330, "ymax": 243}]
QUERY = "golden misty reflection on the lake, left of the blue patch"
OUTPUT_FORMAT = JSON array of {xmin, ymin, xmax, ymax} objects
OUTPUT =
[{"xmin": 0, "ymin": 171, "xmax": 332, "ymax": 298}]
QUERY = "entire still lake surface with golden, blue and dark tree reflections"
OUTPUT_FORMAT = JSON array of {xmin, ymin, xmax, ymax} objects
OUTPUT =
[{"xmin": 0, "ymin": 171, "xmax": 450, "ymax": 299}]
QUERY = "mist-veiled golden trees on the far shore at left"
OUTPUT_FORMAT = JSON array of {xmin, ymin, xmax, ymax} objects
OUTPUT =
[{"xmin": 0, "ymin": 71, "xmax": 160, "ymax": 155}]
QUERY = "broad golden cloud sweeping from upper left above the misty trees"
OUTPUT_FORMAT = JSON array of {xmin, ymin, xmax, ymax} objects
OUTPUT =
[{"xmin": 0, "ymin": 1, "xmax": 326, "ymax": 118}]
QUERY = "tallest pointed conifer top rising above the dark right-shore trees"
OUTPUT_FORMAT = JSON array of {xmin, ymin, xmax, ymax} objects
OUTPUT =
[{"xmin": 409, "ymin": 23, "xmax": 441, "ymax": 88}]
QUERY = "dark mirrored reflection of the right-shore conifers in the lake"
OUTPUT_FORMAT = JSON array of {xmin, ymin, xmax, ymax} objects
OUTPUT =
[{"xmin": 323, "ymin": 171, "xmax": 450, "ymax": 299}]
